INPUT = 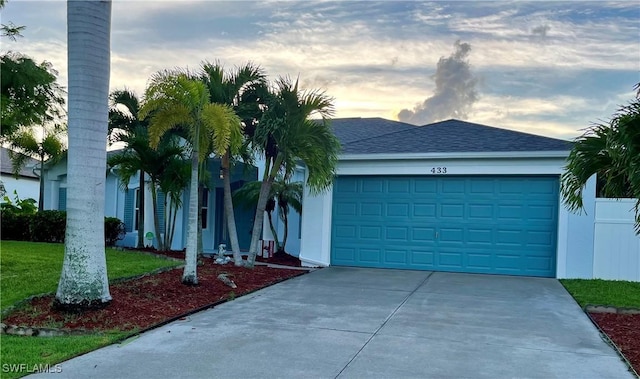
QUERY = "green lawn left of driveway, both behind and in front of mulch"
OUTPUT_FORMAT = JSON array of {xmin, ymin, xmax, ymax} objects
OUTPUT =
[{"xmin": 0, "ymin": 241, "xmax": 181, "ymax": 378}]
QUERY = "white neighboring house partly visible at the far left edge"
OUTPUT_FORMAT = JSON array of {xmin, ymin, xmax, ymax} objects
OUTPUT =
[{"xmin": 0, "ymin": 147, "xmax": 40, "ymax": 202}]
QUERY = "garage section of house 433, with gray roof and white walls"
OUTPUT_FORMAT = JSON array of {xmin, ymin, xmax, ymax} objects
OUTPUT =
[{"xmin": 300, "ymin": 118, "xmax": 595, "ymax": 278}]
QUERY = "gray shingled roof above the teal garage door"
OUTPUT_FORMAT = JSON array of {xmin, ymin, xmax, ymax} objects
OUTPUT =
[{"xmin": 332, "ymin": 118, "xmax": 571, "ymax": 154}]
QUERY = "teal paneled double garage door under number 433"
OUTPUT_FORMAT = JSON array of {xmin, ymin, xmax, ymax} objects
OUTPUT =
[{"xmin": 331, "ymin": 176, "xmax": 559, "ymax": 277}]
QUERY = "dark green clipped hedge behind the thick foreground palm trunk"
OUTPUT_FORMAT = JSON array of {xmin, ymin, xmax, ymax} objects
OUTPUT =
[{"xmin": 0, "ymin": 208, "xmax": 125, "ymax": 246}]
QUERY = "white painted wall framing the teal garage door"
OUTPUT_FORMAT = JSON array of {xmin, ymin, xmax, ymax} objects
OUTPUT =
[{"xmin": 300, "ymin": 153, "xmax": 595, "ymax": 278}]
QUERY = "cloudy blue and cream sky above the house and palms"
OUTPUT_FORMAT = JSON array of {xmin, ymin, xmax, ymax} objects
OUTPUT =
[{"xmin": 0, "ymin": 0, "xmax": 640, "ymax": 139}]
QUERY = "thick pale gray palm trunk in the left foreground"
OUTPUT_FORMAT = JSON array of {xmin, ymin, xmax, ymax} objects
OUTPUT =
[{"xmin": 54, "ymin": 1, "xmax": 111, "ymax": 310}]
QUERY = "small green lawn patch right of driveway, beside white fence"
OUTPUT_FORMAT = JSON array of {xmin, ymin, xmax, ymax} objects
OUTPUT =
[{"xmin": 560, "ymin": 279, "xmax": 640, "ymax": 308}]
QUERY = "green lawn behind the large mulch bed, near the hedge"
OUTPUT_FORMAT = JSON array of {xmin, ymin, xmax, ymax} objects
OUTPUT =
[{"xmin": 0, "ymin": 241, "xmax": 180, "ymax": 309}]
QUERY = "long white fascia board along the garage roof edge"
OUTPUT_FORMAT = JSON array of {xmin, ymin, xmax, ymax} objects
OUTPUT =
[{"xmin": 339, "ymin": 151, "xmax": 569, "ymax": 161}]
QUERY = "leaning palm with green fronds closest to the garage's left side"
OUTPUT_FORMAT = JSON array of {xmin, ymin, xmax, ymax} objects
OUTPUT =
[{"xmin": 247, "ymin": 78, "xmax": 340, "ymax": 266}]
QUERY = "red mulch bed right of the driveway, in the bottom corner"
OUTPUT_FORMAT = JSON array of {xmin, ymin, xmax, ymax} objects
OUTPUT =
[{"xmin": 590, "ymin": 313, "xmax": 640, "ymax": 373}]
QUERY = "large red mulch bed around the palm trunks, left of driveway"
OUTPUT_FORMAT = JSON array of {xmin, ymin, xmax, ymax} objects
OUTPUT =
[{"xmin": 2, "ymin": 253, "xmax": 305, "ymax": 331}]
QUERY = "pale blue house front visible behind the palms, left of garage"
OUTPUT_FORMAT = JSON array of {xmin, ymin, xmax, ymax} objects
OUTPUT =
[{"xmin": 44, "ymin": 152, "xmax": 257, "ymax": 252}]
